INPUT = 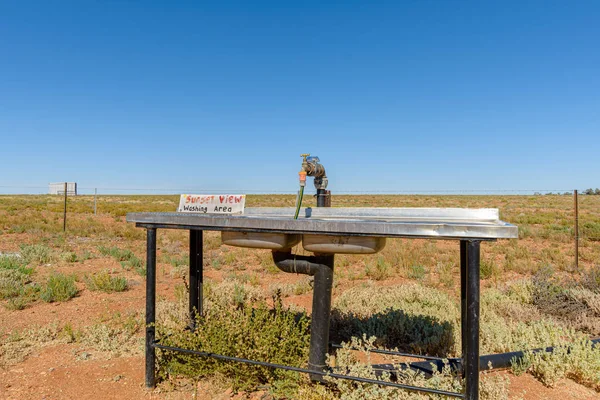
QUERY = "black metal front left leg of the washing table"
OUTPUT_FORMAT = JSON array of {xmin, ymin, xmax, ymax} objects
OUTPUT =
[{"xmin": 146, "ymin": 228, "xmax": 156, "ymax": 388}]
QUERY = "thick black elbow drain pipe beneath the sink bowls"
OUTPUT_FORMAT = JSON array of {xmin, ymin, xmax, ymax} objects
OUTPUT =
[{"xmin": 273, "ymin": 251, "xmax": 334, "ymax": 382}]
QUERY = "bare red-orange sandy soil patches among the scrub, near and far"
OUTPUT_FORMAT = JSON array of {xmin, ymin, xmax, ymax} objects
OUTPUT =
[{"xmin": 0, "ymin": 242, "xmax": 600, "ymax": 400}]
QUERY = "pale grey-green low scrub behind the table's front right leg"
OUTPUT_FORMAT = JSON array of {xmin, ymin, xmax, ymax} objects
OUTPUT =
[{"xmin": 332, "ymin": 281, "xmax": 596, "ymax": 356}]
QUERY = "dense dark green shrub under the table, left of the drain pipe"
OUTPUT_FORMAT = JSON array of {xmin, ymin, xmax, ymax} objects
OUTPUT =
[{"xmin": 157, "ymin": 299, "xmax": 310, "ymax": 390}]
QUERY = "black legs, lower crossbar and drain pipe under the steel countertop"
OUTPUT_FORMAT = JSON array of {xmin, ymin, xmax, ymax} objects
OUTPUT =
[{"xmin": 145, "ymin": 226, "xmax": 481, "ymax": 400}]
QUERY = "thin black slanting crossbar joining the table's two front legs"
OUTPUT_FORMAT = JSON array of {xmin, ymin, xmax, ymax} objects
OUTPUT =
[{"xmin": 153, "ymin": 343, "xmax": 464, "ymax": 399}]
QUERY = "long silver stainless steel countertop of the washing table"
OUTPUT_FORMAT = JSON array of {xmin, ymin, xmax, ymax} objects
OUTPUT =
[{"xmin": 127, "ymin": 207, "xmax": 519, "ymax": 240}]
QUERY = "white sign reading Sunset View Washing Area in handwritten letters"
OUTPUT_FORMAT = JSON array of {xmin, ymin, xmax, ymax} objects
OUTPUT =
[{"xmin": 177, "ymin": 194, "xmax": 246, "ymax": 214}]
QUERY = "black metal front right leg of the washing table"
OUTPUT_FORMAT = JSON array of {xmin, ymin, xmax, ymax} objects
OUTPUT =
[{"xmin": 461, "ymin": 240, "xmax": 480, "ymax": 400}]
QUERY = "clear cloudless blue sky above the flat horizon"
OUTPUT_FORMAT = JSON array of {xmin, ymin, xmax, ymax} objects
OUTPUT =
[{"xmin": 0, "ymin": 0, "xmax": 600, "ymax": 193}]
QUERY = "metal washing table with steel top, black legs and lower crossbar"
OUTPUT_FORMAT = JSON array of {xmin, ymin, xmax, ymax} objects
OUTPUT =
[{"xmin": 127, "ymin": 208, "xmax": 518, "ymax": 400}]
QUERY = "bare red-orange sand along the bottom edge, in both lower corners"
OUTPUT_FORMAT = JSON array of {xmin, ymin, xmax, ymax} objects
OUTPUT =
[{"xmin": 0, "ymin": 344, "xmax": 600, "ymax": 400}]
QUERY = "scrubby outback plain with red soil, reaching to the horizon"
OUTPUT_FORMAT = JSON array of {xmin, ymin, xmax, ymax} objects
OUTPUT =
[{"xmin": 0, "ymin": 193, "xmax": 600, "ymax": 399}]
